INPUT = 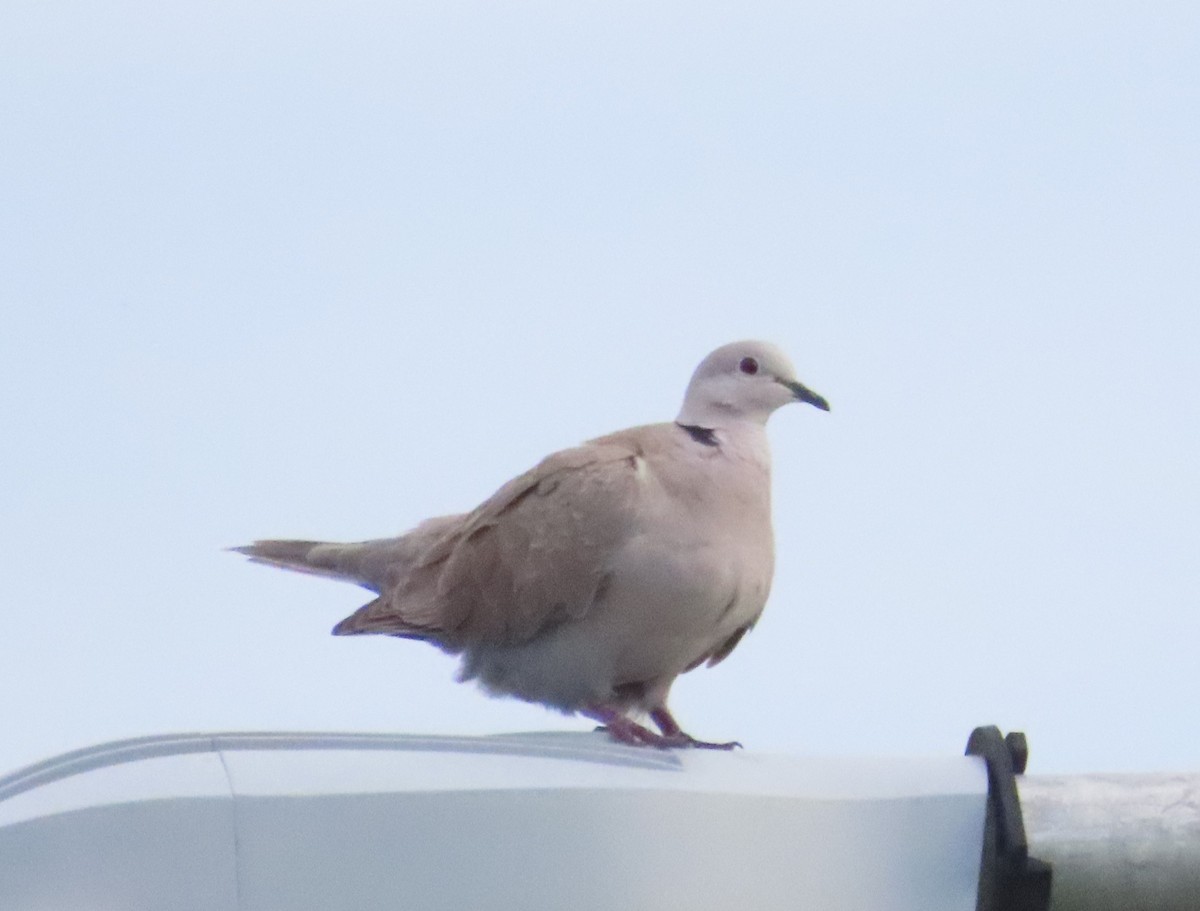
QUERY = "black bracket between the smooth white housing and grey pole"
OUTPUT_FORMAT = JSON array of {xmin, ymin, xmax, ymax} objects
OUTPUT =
[{"xmin": 966, "ymin": 725, "xmax": 1051, "ymax": 911}]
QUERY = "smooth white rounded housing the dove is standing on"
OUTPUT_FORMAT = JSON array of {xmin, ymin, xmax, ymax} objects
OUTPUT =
[{"xmin": 0, "ymin": 733, "xmax": 988, "ymax": 911}]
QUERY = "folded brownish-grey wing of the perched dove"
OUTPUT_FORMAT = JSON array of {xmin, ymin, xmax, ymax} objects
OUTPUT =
[{"xmin": 342, "ymin": 428, "xmax": 649, "ymax": 651}]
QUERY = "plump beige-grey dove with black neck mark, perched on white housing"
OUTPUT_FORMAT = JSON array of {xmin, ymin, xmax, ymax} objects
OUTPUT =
[{"xmin": 237, "ymin": 341, "xmax": 829, "ymax": 749}]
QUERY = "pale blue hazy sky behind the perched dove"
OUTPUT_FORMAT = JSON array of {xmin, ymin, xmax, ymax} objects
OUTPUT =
[{"xmin": 0, "ymin": 0, "xmax": 1200, "ymax": 772}]
